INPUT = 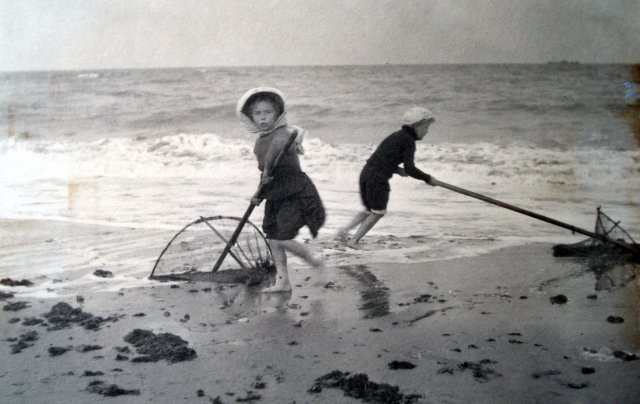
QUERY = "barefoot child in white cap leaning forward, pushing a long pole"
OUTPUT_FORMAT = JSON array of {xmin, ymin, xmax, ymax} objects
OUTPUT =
[{"xmin": 337, "ymin": 107, "xmax": 436, "ymax": 249}]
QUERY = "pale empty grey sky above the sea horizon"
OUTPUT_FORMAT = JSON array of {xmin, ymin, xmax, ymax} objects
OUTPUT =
[{"xmin": 0, "ymin": 0, "xmax": 640, "ymax": 71}]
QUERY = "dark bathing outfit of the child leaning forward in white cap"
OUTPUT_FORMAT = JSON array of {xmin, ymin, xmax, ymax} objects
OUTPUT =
[{"xmin": 360, "ymin": 125, "xmax": 431, "ymax": 211}]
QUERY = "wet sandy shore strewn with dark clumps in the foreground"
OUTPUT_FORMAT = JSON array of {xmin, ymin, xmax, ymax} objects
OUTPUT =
[{"xmin": 0, "ymin": 221, "xmax": 640, "ymax": 403}]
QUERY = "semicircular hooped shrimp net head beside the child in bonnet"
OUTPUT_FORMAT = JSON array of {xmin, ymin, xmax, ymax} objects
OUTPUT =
[{"xmin": 149, "ymin": 216, "xmax": 275, "ymax": 284}]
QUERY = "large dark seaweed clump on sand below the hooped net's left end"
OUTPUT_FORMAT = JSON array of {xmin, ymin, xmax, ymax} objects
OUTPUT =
[{"xmin": 124, "ymin": 328, "xmax": 196, "ymax": 363}]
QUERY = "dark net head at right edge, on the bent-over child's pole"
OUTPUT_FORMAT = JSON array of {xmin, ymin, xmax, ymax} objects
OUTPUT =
[{"xmin": 553, "ymin": 207, "xmax": 640, "ymax": 262}]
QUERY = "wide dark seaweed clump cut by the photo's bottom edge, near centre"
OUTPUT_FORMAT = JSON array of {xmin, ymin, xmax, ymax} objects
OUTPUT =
[{"xmin": 308, "ymin": 370, "xmax": 422, "ymax": 404}]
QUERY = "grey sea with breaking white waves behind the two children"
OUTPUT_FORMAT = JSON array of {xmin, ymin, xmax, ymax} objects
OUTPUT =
[{"xmin": 0, "ymin": 63, "xmax": 640, "ymax": 262}]
